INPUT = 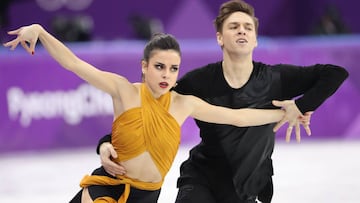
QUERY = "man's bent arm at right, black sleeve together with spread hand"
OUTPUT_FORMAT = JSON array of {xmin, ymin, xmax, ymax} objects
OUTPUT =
[{"xmin": 274, "ymin": 64, "xmax": 349, "ymax": 141}]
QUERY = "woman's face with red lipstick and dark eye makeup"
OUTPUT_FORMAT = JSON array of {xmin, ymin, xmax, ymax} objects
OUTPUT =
[{"xmin": 142, "ymin": 49, "xmax": 181, "ymax": 98}]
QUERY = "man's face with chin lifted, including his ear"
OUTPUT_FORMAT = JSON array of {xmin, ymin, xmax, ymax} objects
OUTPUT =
[{"xmin": 216, "ymin": 12, "xmax": 257, "ymax": 54}]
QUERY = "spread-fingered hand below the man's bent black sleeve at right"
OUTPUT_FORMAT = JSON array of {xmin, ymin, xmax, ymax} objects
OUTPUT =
[{"xmin": 273, "ymin": 100, "xmax": 313, "ymax": 142}]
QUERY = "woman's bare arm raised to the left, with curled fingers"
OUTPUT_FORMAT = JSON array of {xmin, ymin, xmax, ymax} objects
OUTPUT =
[{"xmin": 4, "ymin": 24, "xmax": 130, "ymax": 96}]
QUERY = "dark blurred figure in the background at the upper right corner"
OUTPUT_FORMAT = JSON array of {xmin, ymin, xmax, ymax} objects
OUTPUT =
[{"xmin": 313, "ymin": 5, "xmax": 349, "ymax": 35}]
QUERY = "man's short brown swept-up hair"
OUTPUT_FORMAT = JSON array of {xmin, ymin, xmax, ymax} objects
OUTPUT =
[{"xmin": 214, "ymin": 0, "xmax": 259, "ymax": 34}]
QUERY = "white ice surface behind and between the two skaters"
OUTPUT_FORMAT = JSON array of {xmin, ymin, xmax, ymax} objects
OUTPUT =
[{"xmin": 0, "ymin": 140, "xmax": 360, "ymax": 203}]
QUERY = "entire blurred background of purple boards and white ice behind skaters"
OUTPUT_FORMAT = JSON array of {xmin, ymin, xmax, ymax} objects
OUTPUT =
[{"xmin": 0, "ymin": 0, "xmax": 360, "ymax": 203}]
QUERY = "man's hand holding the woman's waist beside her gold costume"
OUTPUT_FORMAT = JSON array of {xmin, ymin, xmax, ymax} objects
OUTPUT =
[{"xmin": 100, "ymin": 142, "xmax": 126, "ymax": 176}]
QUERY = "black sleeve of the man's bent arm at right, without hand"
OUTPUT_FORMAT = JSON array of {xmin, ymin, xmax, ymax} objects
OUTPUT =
[{"xmin": 280, "ymin": 64, "xmax": 349, "ymax": 113}]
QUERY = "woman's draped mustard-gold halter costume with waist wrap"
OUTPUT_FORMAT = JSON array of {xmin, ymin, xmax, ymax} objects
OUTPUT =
[{"xmin": 80, "ymin": 83, "xmax": 181, "ymax": 203}]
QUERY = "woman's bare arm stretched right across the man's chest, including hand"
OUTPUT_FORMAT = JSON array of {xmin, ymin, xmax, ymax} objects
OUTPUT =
[{"xmin": 182, "ymin": 95, "xmax": 311, "ymax": 141}]
